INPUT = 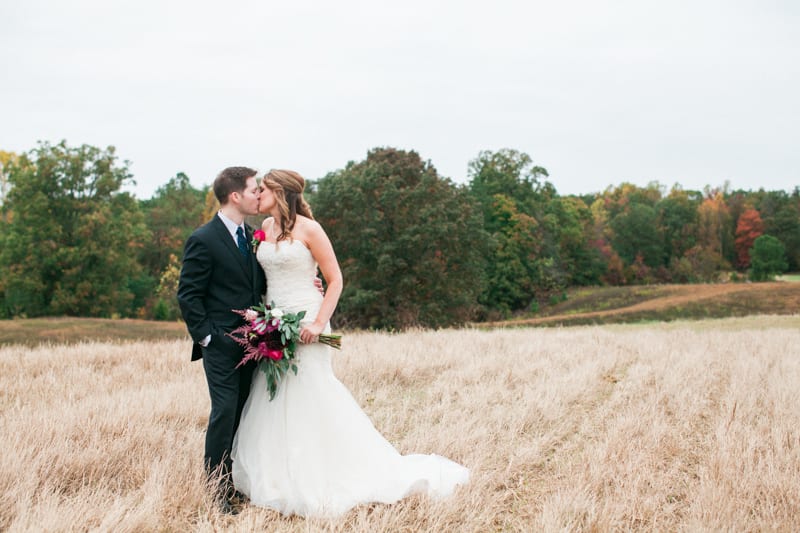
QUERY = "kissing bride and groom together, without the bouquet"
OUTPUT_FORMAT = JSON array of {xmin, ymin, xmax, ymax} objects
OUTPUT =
[{"xmin": 178, "ymin": 167, "xmax": 469, "ymax": 517}]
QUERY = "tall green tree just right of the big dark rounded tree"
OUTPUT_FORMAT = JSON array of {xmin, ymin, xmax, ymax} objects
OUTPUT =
[{"xmin": 469, "ymin": 149, "xmax": 580, "ymax": 313}]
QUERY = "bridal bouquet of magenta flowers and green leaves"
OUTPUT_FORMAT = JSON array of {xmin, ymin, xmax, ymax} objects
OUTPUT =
[{"xmin": 227, "ymin": 302, "xmax": 342, "ymax": 400}]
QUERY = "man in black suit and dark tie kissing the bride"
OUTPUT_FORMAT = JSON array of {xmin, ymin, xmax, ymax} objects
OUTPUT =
[{"xmin": 178, "ymin": 167, "xmax": 266, "ymax": 514}]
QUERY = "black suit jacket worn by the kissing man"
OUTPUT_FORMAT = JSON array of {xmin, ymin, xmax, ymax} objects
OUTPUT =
[{"xmin": 178, "ymin": 215, "xmax": 267, "ymax": 361}]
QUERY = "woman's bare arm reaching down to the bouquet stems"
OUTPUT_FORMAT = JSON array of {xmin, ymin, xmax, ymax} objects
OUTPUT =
[{"xmin": 300, "ymin": 221, "xmax": 343, "ymax": 342}]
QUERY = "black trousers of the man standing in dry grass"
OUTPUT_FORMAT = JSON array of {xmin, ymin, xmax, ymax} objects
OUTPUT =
[{"xmin": 203, "ymin": 333, "xmax": 255, "ymax": 495}]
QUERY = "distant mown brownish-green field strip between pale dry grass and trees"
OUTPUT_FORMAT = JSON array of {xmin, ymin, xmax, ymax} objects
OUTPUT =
[{"xmin": 0, "ymin": 276, "xmax": 800, "ymax": 346}]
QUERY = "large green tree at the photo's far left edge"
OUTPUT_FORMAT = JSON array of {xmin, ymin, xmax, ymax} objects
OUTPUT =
[{"xmin": 0, "ymin": 141, "xmax": 148, "ymax": 316}]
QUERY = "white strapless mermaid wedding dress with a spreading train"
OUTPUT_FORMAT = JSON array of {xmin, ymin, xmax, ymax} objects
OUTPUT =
[{"xmin": 232, "ymin": 240, "xmax": 469, "ymax": 517}]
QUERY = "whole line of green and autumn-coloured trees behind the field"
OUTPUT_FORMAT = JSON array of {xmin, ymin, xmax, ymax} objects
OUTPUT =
[{"xmin": 0, "ymin": 142, "xmax": 800, "ymax": 328}]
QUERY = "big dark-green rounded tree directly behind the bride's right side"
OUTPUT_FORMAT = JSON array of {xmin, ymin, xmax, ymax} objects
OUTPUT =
[{"xmin": 309, "ymin": 148, "xmax": 487, "ymax": 328}]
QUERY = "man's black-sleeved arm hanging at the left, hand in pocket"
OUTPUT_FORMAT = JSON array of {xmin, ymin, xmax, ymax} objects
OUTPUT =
[{"xmin": 178, "ymin": 234, "xmax": 213, "ymax": 343}]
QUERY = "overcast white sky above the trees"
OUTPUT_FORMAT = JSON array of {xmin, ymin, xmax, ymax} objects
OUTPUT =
[{"xmin": 0, "ymin": 0, "xmax": 800, "ymax": 198}]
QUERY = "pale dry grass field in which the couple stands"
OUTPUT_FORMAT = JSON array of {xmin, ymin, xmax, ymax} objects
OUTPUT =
[{"xmin": 0, "ymin": 315, "xmax": 800, "ymax": 532}]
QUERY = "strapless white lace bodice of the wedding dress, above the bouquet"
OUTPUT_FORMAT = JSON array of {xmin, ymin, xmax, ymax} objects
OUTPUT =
[{"xmin": 256, "ymin": 240, "xmax": 322, "ymax": 322}]
